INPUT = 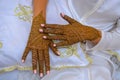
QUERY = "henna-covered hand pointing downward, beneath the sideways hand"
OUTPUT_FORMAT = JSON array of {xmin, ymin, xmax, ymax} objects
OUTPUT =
[{"xmin": 22, "ymin": 13, "xmax": 58, "ymax": 77}]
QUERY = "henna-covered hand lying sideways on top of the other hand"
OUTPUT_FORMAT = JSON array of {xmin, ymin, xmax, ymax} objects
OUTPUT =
[{"xmin": 42, "ymin": 14, "xmax": 101, "ymax": 47}]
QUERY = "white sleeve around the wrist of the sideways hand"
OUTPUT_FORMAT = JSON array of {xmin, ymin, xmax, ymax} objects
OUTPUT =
[{"xmin": 86, "ymin": 19, "xmax": 120, "ymax": 50}]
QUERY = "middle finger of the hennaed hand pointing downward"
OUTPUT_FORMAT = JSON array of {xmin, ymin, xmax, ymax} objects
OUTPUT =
[{"xmin": 38, "ymin": 50, "xmax": 44, "ymax": 77}]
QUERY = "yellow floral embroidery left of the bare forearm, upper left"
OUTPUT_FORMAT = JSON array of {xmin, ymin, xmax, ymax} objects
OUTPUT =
[{"xmin": 15, "ymin": 4, "xmax": 32, "ymax": 22}]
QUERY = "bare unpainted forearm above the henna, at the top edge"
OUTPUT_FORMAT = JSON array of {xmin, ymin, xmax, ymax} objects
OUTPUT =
[{"xmin": 33, "ymin": 0, "xmax": 48, "ymax": 18}]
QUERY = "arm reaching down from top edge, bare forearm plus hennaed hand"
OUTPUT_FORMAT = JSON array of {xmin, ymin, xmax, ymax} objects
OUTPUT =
[{"xmin": 22, "ymin": 0, "xmax": 59, "ymax": 77}]
